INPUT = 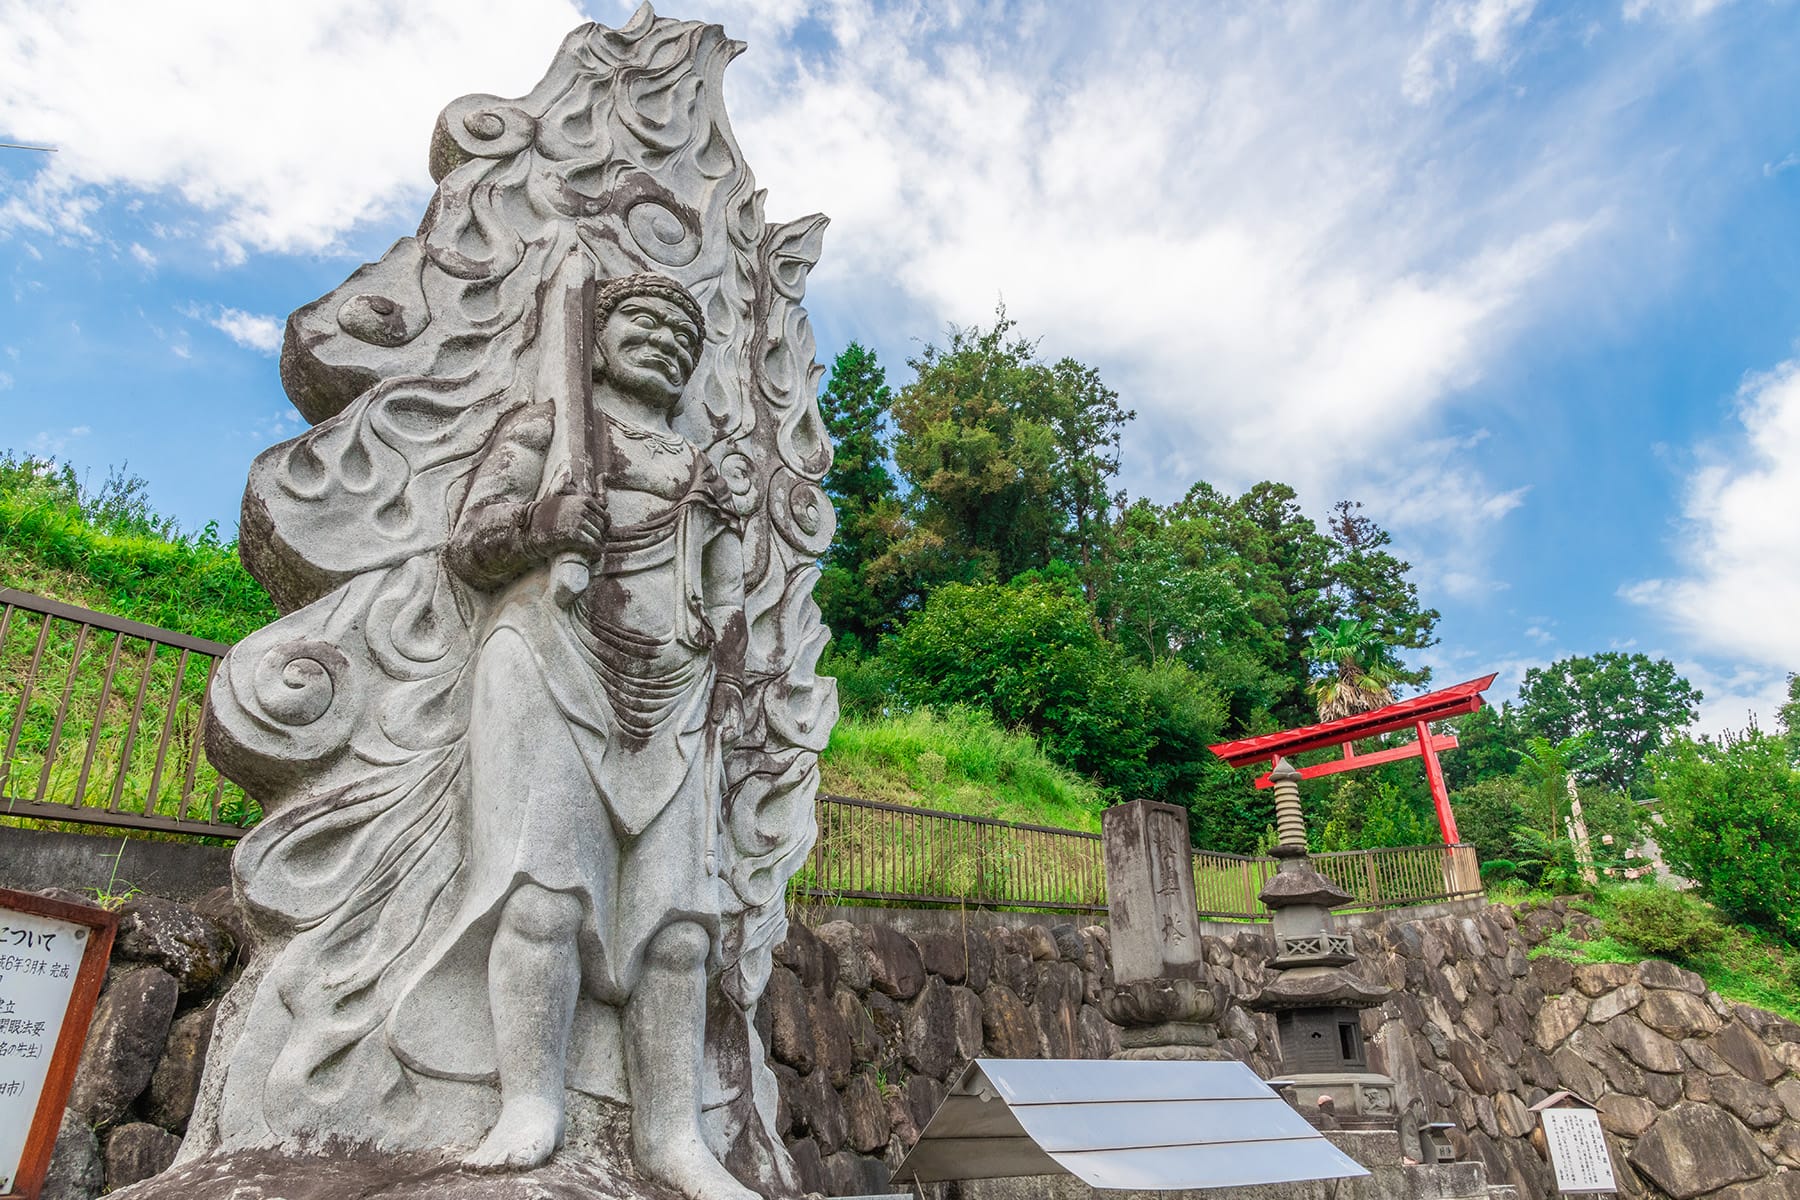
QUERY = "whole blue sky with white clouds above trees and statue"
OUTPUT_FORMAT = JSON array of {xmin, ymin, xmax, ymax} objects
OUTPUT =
[{"xmin": 0, "ymin": 0, "xmax": 1800, "ymax": 729}]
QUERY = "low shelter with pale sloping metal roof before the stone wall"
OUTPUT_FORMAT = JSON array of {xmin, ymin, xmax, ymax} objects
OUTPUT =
[{"xmin": 895, "ymin": 1058, "xmax": 1368, "ymax": 1191}]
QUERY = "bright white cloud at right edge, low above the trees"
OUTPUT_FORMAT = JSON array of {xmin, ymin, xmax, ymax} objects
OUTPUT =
[{"xmin": 1620, "ymin": 358, "xmax": 1800, "ymax": 665}]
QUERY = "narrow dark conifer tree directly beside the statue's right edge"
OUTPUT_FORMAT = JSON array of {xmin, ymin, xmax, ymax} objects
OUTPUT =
[{"xmin": 814, "ymin": 342, "xmax": 905, "ymax": 648}]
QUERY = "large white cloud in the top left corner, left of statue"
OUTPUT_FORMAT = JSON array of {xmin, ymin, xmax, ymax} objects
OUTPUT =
[{"xmin": 0, "ymin": 0, "xmax": 583, "ymax": 259}]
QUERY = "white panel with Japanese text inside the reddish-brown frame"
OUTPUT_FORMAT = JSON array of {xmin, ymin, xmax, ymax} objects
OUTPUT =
[{"xmin": 0, "ymin": 910, "xmax": 88, "ymax": 1195}]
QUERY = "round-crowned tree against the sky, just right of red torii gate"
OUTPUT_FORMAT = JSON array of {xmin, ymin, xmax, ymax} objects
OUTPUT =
[{"xmin": 1519, "ymin": 651, "xmax": 1703, "ymax": 797}]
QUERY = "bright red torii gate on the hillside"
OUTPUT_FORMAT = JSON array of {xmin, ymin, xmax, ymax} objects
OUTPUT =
[{"xmin": 1208, "ymin": 671, "xmax": 1499, "ymax": 846}]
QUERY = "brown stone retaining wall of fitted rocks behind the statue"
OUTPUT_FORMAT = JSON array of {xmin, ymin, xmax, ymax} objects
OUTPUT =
[{"xmin": 28, "ymin": 892, "xmax": 1800, "ymax": 1200}]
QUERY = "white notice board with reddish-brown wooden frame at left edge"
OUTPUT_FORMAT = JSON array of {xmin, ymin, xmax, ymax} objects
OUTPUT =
[{"xmin": 0, "ymin": 887, "xmax": 119, "ymax": 1200}]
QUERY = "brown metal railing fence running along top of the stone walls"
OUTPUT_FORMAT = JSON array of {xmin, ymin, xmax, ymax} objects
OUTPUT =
[{"xmin": 0, "ymin": 588, "xmax": 1481, "ymax": 921}]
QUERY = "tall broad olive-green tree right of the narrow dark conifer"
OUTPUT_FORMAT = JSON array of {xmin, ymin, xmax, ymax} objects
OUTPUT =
[{"xmin": 893, "ymin": 308, "xmax": 1134, "ymax": 588}]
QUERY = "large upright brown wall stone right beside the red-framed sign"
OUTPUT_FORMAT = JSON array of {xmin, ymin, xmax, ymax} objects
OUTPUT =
[{"xmin": 68, "ymin": 966, "xmax": 180, "ymax": 1126}]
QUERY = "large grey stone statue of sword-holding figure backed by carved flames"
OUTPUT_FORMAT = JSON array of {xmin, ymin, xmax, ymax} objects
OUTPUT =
[{"xmin": 154, "ymin": 5, "xmax": 837, "ymax": 1200}]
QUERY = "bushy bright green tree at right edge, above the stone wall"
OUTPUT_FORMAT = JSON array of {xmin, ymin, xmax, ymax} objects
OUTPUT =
[{"xmin": 1649, "ymin": 730, "xmax": 1800, "ymax": 945}]
